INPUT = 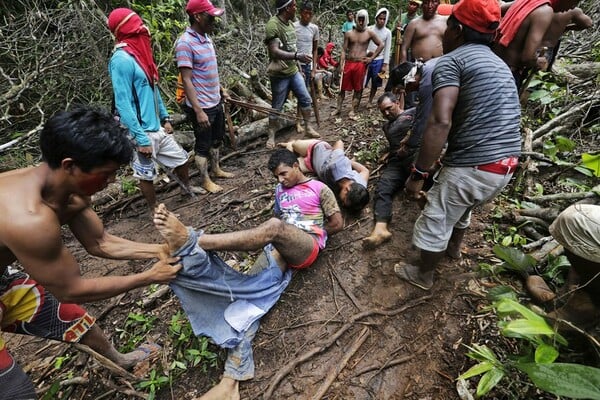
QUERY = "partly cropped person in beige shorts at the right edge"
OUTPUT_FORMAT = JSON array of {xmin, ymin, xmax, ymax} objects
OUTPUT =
[{"xmin": 548, "ymin": 204, "xmax": 600, "ymax": 328}]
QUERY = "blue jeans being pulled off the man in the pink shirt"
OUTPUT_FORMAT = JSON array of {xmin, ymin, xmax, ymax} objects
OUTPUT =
[{"xmin": 169, "ymin": 228, "xmax": 292, "ymax": 380}]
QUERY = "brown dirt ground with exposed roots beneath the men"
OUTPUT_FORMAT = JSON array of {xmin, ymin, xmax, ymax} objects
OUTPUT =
[{"xmin": 10, "ymin": 98, "xmax": 506, "ymax": 400}]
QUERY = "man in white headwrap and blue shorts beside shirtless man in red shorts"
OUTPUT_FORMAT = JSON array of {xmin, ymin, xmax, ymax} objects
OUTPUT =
[{"xmin": 365, "ymin": 8, "xmax": 392, "ymax": 104}]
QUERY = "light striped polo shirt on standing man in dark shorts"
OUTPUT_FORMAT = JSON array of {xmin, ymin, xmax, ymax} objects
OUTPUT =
[{"xmin": 175, "ymin": 27, "xmax": 221, "ymax": 109}]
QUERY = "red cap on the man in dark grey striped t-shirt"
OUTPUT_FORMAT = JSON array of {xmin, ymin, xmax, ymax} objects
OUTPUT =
[{"xmin": 452, "ymin": 0, "xmax": 500, "ymax": 33}]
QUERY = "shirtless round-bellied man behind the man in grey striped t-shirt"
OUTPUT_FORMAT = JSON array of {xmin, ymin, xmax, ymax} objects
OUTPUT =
[{"xmin": 400, "ymin": 0, "xmax": 447, "ymax": 64}]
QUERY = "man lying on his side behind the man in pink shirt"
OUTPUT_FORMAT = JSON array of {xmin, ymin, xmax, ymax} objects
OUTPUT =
[{"xmin": 277, "ymin": 139, "xmax": 370, "ymax": 212}]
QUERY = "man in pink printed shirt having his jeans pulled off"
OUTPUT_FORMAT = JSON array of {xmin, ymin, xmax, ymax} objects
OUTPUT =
[{"xmin": 154, "ymin": 149, "xmax": 343, "ymax": 400}]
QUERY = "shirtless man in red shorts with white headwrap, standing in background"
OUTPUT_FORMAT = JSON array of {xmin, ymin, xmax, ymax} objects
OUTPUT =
[{"xmin": 331, "ymin": 10, "xmax": 384, "ymax": 120}]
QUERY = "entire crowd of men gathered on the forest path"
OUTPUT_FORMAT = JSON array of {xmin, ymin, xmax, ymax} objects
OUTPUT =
[{"xmin": 0, "ymin": 0, "xmax": 600, "ymax": 400}]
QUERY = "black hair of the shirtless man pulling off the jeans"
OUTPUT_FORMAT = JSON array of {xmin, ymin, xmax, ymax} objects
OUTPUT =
[{"xmin": 40, "ymin": 106, "xmax": 134, "ymax": 172}]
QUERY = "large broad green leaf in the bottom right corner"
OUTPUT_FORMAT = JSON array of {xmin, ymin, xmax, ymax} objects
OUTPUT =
[{"xmin": 515, "ymin": 363, "xmax": 600, "ymax": 400}]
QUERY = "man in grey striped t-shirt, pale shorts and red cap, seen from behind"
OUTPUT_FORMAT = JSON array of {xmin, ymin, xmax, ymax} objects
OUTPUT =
[{"xmin": 394, "ymin": 0, "xmax": 521, "ymax": 290}]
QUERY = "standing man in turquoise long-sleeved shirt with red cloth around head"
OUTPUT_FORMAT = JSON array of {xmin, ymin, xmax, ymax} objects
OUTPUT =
[{"xmin": 108, "ymin": 8, "xmax": 206, "ymax": 210}]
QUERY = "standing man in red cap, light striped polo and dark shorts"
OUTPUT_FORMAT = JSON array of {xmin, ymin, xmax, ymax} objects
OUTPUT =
[{"xmin": 175, "ymin": 0, "xmax": 233, "ymax": 193}]
